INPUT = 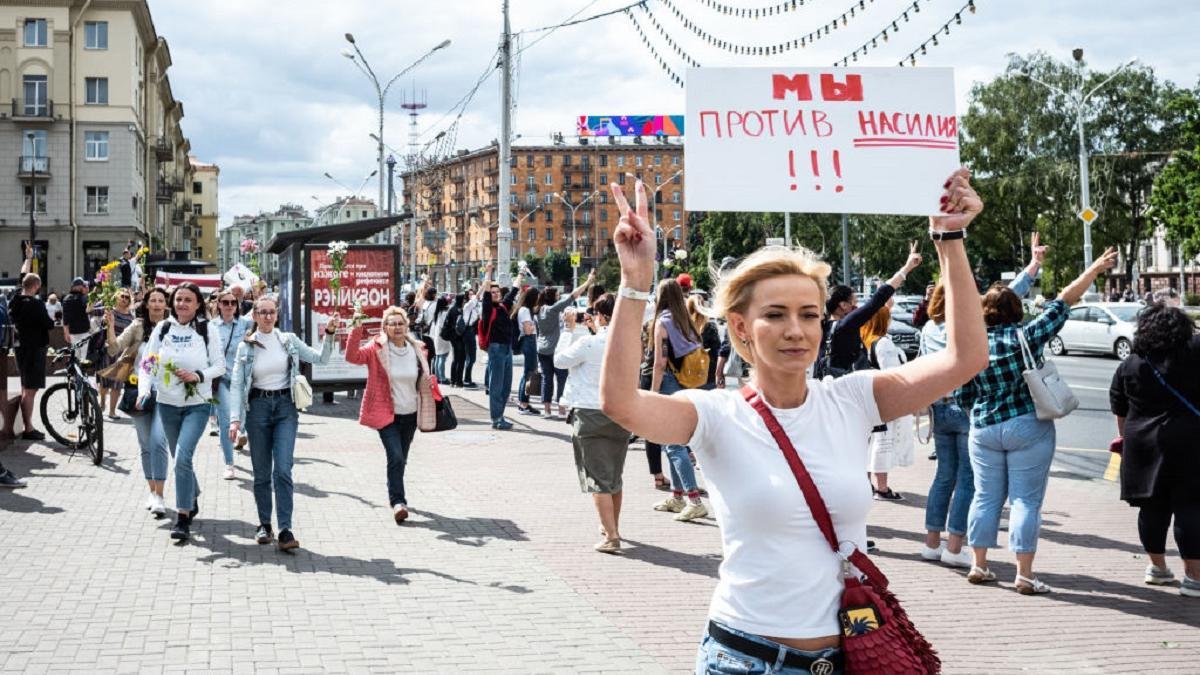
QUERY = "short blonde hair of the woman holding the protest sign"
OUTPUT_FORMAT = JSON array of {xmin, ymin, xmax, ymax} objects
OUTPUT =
[{"xmin": 710, "ymin": 246, "xmax": 830, "ymax": 364}]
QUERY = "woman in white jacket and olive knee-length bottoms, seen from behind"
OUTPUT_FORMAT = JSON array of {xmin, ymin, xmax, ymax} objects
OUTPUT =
[{"xmin": 554, "ymin": 293, "xmax": 629, "ymax": 554}]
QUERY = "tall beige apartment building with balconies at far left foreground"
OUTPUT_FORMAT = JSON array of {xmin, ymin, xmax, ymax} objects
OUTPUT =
[{"xmin": 0, "ymin": 0, "xmax": 191, "ymax": 289}]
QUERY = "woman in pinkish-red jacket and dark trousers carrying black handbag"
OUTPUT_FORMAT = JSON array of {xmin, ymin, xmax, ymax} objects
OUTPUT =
[{"xmin": 346, "ymin": 307, "xmax": 433, "ymax": 525}]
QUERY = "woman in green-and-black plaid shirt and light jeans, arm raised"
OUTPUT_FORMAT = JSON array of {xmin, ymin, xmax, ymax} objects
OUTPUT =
[{"xmin": 959, "ymin": 249, "xmax": 1117, "ymax": 595}]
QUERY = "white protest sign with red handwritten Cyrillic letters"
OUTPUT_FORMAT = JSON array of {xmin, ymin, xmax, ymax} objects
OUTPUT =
[{"xmin": 684, "ymin": 67, "xmax": 959, "ymax": 215}]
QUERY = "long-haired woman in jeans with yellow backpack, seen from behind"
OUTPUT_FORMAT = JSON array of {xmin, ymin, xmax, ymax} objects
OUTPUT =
[{"xmin": 650, "ymin": 279, "xmax": 708, "ymax": 522}]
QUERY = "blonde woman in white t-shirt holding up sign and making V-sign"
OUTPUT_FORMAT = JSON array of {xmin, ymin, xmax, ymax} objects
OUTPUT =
[{"xmin": 600, "ymin": 169, "xmax": 988, "ymax": 673}]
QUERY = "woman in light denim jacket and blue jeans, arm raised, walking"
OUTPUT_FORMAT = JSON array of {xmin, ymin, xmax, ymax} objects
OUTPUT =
[{"xmin": 229, "ymin": 298, "xmax": 340, "ymax": 551}]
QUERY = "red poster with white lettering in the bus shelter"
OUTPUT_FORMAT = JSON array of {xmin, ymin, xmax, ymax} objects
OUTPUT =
[{"xmin": 307, "ymin": 245, "xmax": 396, "ymax": 384}]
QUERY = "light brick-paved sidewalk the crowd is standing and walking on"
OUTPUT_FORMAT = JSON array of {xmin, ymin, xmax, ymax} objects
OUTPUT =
[{"xmin": 0, "ymin": 381, "xmax": 1200, "ymax": 674}]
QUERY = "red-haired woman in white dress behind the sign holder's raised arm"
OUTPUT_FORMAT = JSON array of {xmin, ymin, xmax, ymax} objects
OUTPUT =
[{"xmin": 858, "ymin": 301, "xmax": 913, "ymax": 502}]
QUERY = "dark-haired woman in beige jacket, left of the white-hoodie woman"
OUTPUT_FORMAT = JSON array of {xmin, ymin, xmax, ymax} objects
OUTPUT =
[{"xmin": 104, "ymin": 287, "xmax": 170, "ymax": 518}]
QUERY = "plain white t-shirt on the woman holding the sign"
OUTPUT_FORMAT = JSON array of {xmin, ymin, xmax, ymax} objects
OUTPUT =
[{"xmin": 683, "ymin": 371, "xmax": 880, "ymax": 638}]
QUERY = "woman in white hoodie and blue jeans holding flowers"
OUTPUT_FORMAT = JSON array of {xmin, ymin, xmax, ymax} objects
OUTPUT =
[{"xmin": 137, "ymin": 281, "xmax": 226, "ymax": 540}]
